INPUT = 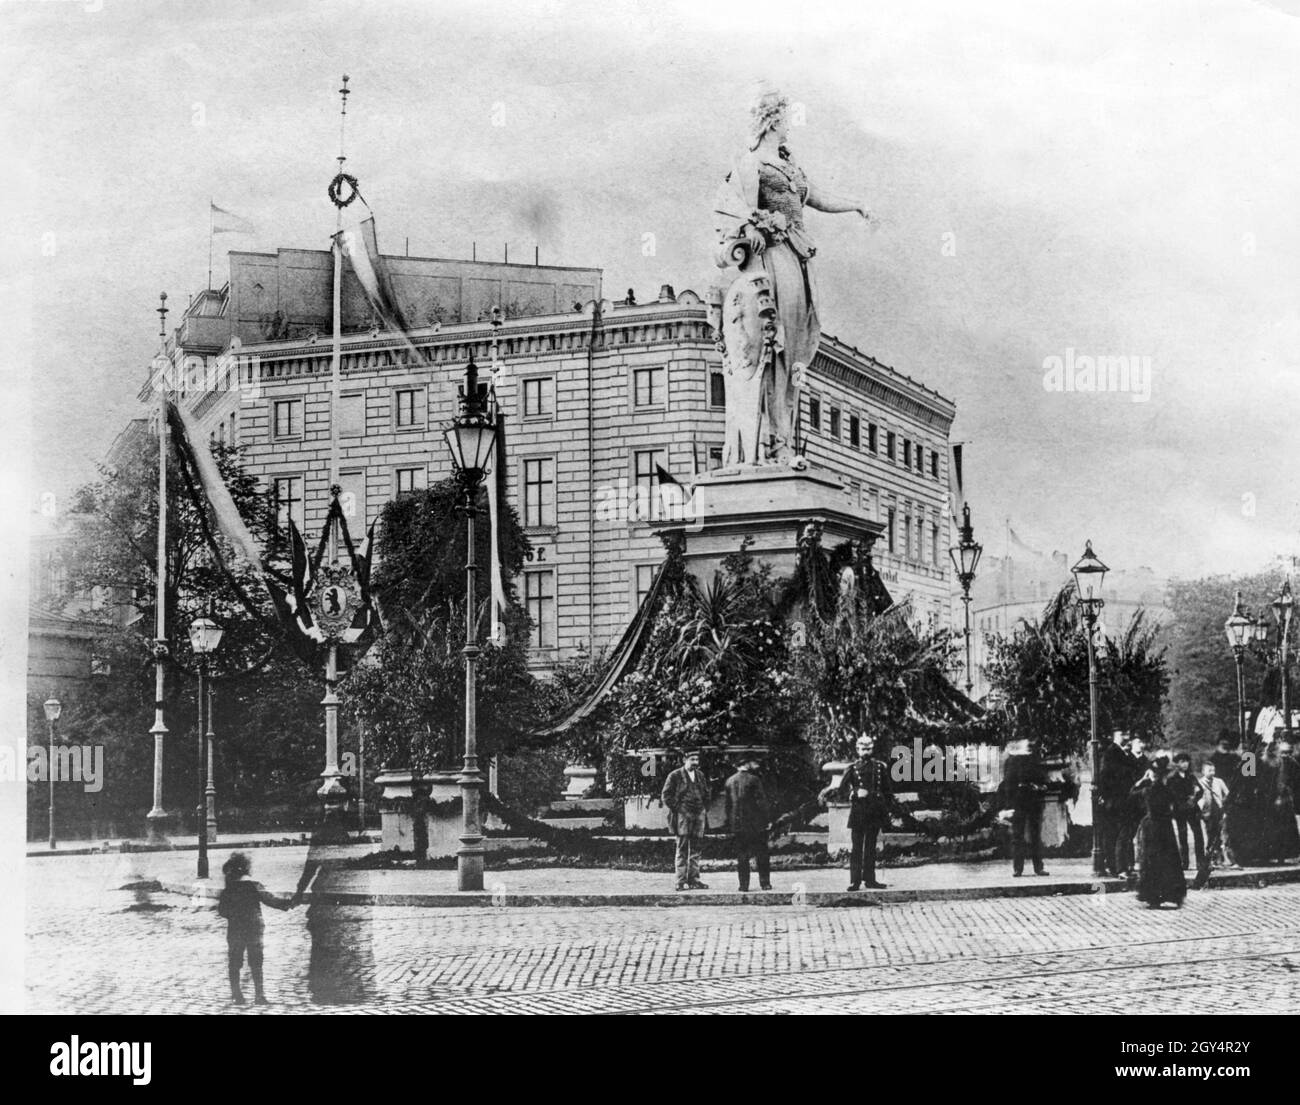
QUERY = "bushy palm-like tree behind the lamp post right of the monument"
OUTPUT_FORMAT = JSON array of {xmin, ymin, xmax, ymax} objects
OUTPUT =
[{"xmin": 984, "ymin": 584, "xmax": 1169, "ymax": 758}]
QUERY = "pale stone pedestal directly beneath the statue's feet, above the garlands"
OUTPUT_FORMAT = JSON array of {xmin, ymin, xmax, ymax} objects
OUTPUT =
[{"xmin": 660, "ymin": 464, "xmax": 884, "ymax": 580}]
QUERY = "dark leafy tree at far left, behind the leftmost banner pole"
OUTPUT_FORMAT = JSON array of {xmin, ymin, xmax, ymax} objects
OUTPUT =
[{"xmin": 61, "ymin": 436, "xmax": 322, "ymax": 823}]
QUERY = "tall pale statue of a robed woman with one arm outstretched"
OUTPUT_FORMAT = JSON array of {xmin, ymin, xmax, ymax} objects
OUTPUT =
[{"xmin": 712, "ymin": 92, "xmax": 870, "ymax": 468}]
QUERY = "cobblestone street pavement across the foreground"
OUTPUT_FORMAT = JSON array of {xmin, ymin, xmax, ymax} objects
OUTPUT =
[{"xmin": 26, "ymin": 855, "xmax": 1300, "ymax": 1015}]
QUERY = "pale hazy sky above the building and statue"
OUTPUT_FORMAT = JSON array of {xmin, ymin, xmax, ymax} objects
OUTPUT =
[{"xmin": 0, "ymin": 0, "xmax": 1300, "ymax": 577}]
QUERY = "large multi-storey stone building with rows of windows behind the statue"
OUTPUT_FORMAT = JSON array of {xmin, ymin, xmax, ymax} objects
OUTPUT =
[{"xmin": 140, "ymin": 243, "xmax": 954, "ymax": 668}]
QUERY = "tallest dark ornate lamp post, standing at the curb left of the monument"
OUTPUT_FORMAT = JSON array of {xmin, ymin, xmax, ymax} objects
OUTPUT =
[{"xmin": 445, "ymin": 354, "xmax": 497, "ymax": 891}]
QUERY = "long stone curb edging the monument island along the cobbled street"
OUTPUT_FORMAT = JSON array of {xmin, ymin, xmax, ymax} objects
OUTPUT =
[{"xmin": 156, "ymin": 867, "xmax": 1300, "ymax": 909}]
